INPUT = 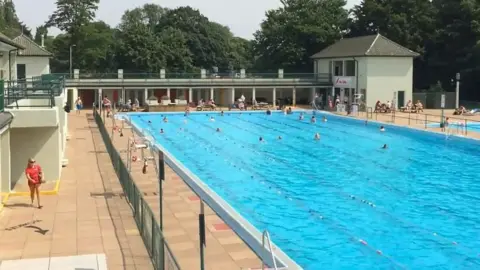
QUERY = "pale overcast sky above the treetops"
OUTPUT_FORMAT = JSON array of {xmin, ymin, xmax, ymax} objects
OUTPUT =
[{"xmin": 13, "ymin": 0, "xmax": 361, "ymax": 39}]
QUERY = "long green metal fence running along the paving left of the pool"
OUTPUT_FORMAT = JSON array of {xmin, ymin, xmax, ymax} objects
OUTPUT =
[{"xmin": 93, "ymin": 108, "xmax": 180, "ymax": 270}]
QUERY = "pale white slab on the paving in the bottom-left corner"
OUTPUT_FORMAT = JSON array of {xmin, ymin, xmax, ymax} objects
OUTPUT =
[{"xmin": 0, "ymin": 254, "xmax": 107, "ymax": 270}]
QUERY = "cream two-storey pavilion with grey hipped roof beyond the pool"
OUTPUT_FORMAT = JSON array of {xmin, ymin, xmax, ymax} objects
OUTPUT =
[{"xmin": 312, "ymin": 34, "xmax": 419, "ymax": 108}]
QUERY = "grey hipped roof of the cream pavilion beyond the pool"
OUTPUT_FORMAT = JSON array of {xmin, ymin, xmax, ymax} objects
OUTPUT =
[{"xmin": 311, "ymin": 34, "xmax": 419, "ymax": 59}]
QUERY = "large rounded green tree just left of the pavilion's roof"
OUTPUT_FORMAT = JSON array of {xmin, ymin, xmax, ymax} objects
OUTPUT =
[{"xmin": 254, "ymin": 0, "xmax": 348, "ymax": 71}]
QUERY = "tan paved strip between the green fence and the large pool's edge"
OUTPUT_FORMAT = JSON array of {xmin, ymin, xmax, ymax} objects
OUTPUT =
[{"xmin": 106, "ymin": 113, "xmax": 262, "ymax": 270}]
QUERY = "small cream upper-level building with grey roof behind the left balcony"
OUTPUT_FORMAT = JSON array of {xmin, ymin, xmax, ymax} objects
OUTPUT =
[{"xmin": 13, "ymin": 34, "xmax": 52, "ymax": 80}]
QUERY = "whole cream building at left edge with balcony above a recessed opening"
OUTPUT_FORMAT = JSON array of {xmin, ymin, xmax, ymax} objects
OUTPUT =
[{"xmin": 0, "ymin": 33, "xmax": 67, "ymax": 196}]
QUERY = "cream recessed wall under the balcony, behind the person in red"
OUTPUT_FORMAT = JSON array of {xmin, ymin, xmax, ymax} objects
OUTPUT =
[{"xmin": 10, "ymin": 127, "xmax": 62, "ymax": 186}]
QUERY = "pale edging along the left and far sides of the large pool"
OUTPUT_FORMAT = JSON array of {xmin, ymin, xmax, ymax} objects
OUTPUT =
[{"xmin": 124, "ymin": 111, "xmax": 303, "ymax": 270}]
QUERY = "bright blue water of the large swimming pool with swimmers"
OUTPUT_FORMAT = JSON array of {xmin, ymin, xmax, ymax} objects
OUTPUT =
[{"xmin": 131, "ymin": 110, "xmax": 480, "ymax": 270}]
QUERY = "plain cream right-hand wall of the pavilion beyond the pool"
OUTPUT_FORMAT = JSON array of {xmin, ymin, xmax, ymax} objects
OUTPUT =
[{"xmin": 366, "ymin": 57, "xmax": 413, "ymax": 107}]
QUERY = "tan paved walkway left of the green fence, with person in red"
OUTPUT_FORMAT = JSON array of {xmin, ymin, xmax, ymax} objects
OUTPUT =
[{"xmin": 0, "ymin": 113, "xmax": 153, "ymax": 270}]
